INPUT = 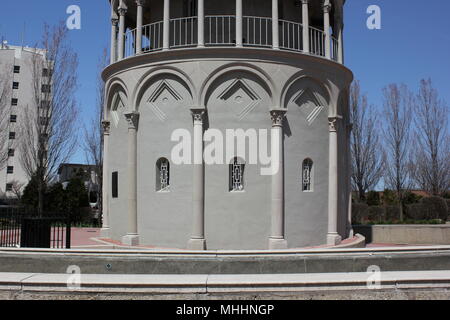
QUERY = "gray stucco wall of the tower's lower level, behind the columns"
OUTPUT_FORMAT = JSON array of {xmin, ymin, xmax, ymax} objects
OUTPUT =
[{"xmin": 105, "ymin": 48, "xmax": 351, "ymax": 249}]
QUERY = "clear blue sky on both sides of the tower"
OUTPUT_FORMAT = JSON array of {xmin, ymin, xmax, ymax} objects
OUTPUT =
[{"xmin": 0, "ymin": 0, "xmax": 450, "ymax": 162}]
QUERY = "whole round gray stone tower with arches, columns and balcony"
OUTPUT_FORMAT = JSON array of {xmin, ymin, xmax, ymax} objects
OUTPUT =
[{"xmin": 103, "ymin": 0, "xmax": 353, "ymax": 250}]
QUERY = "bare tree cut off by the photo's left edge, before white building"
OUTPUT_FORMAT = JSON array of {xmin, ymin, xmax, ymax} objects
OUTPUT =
[{"xmin": 0, "ymin": 64, "xmax": 12, "ymax": 170}]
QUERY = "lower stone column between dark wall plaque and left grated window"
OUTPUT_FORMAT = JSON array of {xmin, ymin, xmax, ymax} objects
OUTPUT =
[{"xmin": 122, "ymin": 111, "xmax": 139, "ymax": 246}]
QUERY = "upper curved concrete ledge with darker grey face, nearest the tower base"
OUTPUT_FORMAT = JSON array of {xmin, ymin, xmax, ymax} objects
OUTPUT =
[{"xmin": 0, "ymin": 246, "xmax": 450, "ymax": 274}]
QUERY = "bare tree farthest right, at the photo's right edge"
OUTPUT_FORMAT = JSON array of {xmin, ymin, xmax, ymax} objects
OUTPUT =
[{"xmin": 414, "ymin": 79, "xmax": 450, "ymax": 195}]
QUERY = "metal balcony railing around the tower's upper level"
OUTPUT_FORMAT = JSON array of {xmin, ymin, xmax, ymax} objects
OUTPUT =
[{"xmin": 124, "ymin": 15, "xmax": 339, "ymax": 61}]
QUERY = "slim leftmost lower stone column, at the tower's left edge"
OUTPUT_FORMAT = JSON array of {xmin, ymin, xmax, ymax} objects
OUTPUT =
[{"xmin": 101, "ymin": 121, "xmax": 111, "ymax": 238}]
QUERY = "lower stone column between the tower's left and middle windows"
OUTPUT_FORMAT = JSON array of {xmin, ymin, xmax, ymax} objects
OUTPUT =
[{"xmin": 188, "ymin": 107, "xmax": 206, "ymax": 250}]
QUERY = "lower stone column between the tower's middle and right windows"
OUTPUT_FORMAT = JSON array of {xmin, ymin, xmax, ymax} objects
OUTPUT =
[{"xmin": 269, "ymin": 109, "xmax": 288, "ymax": 250}]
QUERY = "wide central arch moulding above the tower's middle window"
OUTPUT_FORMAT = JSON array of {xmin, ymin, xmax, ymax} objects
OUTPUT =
[{"xmin": 198, "ymin": 63, "xmax": 277, "ymax": 107}]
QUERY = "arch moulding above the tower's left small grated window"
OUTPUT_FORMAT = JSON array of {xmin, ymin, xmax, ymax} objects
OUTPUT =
[{"xmin": 132, "ymin": 67, "xmax": 197, "ymax": 111}]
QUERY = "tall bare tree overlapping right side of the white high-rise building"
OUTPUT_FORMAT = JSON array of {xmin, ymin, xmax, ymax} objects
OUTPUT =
[{"xmin": 20, "ymin": 23, "xmax": 78, "ymax": 214}]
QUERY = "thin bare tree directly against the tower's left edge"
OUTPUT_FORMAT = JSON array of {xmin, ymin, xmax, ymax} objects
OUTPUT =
[{"xmin": 83, "ymin": 49, "xmax": 109, "ymax": 220}]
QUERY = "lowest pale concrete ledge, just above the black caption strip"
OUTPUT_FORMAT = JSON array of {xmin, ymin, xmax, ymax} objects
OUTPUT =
[{"xmin": 0, "ymin": 270, "xmax": 450, "ymax": 295}]
